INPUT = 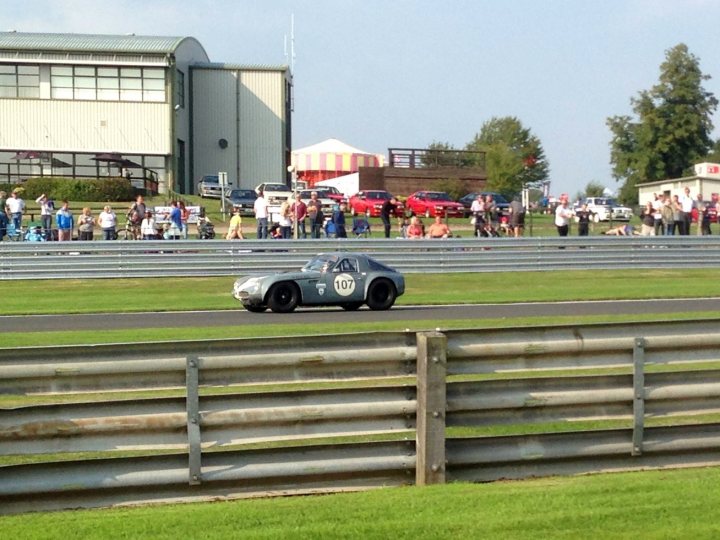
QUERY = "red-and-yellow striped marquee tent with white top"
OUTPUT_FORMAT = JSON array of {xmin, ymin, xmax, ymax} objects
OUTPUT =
[{"xmin": 292, "ymin": 139, "xmax": 383, "ymax": 186}]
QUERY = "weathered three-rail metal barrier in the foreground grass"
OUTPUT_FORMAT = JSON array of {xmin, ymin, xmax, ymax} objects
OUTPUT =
[{"xmin": 0, "ymin": 320, "xmax": 720, "ymax": 513}]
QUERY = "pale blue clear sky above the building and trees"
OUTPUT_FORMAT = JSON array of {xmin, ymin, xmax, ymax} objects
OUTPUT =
[{"xmin": 0, "ymin": 0, "xmax": 720, "ymax": 195}]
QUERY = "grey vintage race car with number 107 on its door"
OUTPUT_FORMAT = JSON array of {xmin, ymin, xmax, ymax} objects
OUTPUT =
[{"xmin": 232, "ymin": 252, "xmax": 405, "ymax": 313}]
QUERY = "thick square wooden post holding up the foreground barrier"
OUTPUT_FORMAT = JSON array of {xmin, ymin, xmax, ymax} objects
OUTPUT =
[{"xmin": 415, "ymin": 332, "xmax": 447, "ymax": 486}]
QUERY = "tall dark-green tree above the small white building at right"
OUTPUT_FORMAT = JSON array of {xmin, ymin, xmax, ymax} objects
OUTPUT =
[{"xmin": 607, "ymin": 43, "xmax": 718, "ymax": 203}]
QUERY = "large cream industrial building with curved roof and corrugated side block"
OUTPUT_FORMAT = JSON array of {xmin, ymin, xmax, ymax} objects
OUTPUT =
[{"xmin": 0, "ymin": 32, "xmax": 292, "ymax": 193}]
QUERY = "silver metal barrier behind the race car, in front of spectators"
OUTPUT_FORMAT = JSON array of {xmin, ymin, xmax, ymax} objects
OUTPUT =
[{"xmin": 0, "ymin": 236, "xmax": 720, "ymax": 280}]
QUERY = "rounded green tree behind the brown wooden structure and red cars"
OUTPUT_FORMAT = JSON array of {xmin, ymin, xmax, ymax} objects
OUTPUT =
[{"xmin": 466, "ymin": 116, "xmax": 549, "ymax": 196}]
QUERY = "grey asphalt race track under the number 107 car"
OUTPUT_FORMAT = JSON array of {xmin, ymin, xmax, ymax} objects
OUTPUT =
[{"xmin": 0, "ymin": 298, "xmax": 720, "ymax": 333}]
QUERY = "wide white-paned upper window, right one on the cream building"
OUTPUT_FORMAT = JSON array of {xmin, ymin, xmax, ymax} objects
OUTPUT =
[{"xmin": 50, "ymin": 66, "xmax": 165, "ymax": 102}]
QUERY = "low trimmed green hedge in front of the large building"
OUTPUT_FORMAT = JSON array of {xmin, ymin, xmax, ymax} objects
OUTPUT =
[{"xmin": 0, "ymin": 177, "xmax": 135, "ymax": 202}]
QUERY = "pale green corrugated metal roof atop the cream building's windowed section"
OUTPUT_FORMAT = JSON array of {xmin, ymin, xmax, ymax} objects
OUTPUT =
[{"xmin": 0, "ymin": 32, "xmax": 195, "ymax": 54}]
